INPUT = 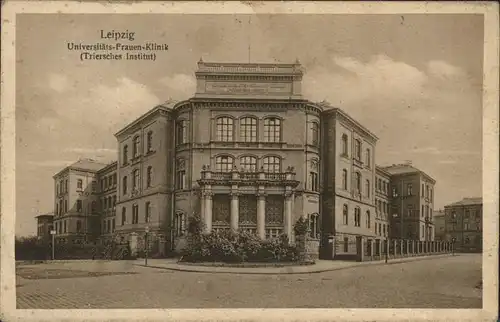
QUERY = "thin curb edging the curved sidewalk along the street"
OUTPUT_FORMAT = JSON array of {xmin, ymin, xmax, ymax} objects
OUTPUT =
[{"xmin": 134, "ymin": 254, "xmax": 457, "ymax": 275}]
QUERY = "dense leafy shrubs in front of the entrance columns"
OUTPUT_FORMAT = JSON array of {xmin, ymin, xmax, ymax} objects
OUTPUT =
[{"xmin": 182, "ymin": 231, "xmax": 298, "ymax": 263}]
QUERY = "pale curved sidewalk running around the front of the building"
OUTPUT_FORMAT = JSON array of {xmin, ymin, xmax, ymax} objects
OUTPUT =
[{"xmin": 134, "ymin": 254, "xmax": 458, "ymax": 274}]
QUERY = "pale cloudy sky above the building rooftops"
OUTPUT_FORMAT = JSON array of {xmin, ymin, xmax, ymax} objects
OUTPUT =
[{"xmin": 16, "ymin": 14, "xmax": 483, "ymax": 236}]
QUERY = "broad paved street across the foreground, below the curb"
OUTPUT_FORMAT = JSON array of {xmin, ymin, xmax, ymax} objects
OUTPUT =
[{"xmin": 17, "ymin": 255, "xmax": 482, "ymax": 309}]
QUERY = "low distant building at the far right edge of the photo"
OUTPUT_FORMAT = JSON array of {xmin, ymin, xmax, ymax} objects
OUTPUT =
[{"xmin": 444, "ymin": 198, "xmax": 483, "ymax": 252}]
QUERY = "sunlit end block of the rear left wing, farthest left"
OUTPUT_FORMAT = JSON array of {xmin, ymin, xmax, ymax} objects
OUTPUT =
[{"xmin": 54, "ymin": 159, "xmax": 106, "ymax": 244}]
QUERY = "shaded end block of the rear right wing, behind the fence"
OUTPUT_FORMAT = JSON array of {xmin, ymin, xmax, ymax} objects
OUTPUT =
[{"xmin": 383, "ymin": 164, "xmax": 436, "ymax": 241}]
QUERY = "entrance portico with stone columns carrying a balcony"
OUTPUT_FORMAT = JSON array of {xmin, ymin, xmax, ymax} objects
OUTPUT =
[{"xmin": 198, "ymin": 166, "xmax": 299, "ymax": 239}]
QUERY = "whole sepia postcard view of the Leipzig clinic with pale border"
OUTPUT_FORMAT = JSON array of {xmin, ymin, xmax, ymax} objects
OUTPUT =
[{"xmin": 1, "ymin": 2, "xmax": 498, "ymax": 321}]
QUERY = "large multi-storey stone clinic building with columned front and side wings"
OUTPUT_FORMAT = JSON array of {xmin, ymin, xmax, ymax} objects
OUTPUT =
[{"xmin": 47, "ymin": 61, "xmax": 434, "ymax": 257}]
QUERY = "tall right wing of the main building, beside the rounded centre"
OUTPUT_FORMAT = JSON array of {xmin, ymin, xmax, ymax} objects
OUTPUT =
[{"xmin": 322, "ymin": 108, "xmax": 378, "ymax": 254}]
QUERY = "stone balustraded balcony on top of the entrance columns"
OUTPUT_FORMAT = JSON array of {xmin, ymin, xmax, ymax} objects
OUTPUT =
[{"xmin": 198, "ymin": 166, "xmax": 299, "ymax": 187}]
